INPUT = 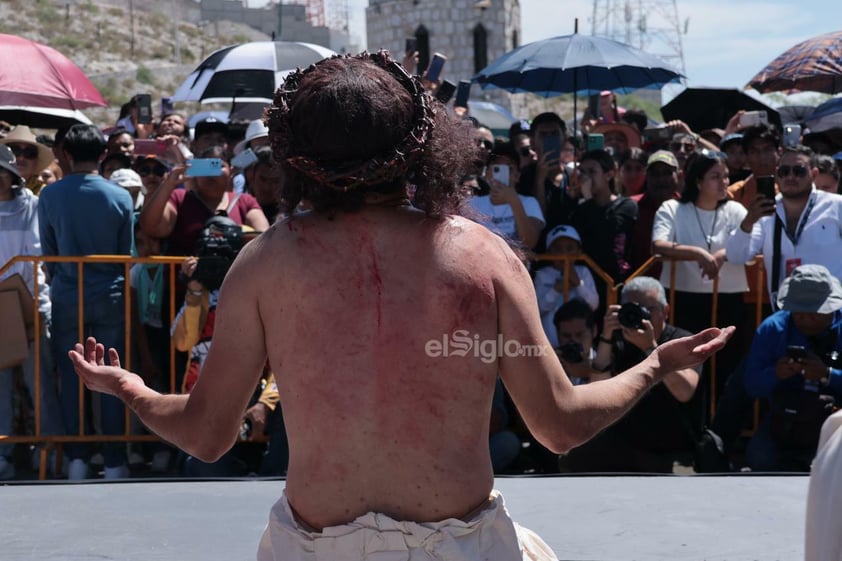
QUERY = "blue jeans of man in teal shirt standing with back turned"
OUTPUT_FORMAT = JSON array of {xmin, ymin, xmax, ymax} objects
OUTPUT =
[{"xmin": 53, "ymin": 294, "xmax": 127, "ymax": 467}]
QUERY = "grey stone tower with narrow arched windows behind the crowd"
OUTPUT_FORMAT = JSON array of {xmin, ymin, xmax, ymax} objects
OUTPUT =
[{"xmin": 366, "ymin": 0, "xmax": 523, "ymax": 115}]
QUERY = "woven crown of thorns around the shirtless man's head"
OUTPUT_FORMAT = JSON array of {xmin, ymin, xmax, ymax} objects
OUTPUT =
[{"xmin": 269, "ymin": 50, "xmax": 435, "ymax": 192}]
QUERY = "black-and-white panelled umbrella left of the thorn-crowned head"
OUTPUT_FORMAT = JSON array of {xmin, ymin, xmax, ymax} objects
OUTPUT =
[{"xmin": 173, "ymin": 41, "xmax": 336, "ymax": 103}]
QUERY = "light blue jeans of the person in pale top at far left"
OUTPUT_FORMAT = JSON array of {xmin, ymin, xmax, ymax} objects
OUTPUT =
[{"xmin": 0, "ymin": 324, "xmax": 63, "ymax": 458}]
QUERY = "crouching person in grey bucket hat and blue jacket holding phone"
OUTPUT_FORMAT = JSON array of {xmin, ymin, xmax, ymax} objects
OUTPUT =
[{"xmin": 745, "ymin": 265, "xmax": 842, "ymax": 471}]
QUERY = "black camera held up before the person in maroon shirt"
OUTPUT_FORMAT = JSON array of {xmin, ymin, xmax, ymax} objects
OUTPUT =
[{"xmin": 192, "ymin": 216, "xmax": 243, "ymax": 290}]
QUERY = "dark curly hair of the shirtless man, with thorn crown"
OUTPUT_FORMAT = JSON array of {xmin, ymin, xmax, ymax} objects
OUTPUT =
[{"xmin": 267, "ymin": 52, "xmax": 477, "ymax": 217}]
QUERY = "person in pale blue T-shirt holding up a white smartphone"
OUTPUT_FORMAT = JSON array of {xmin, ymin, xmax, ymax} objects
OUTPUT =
[{"xmin": 470, "ymin": 142, "xmax": 544, "ymax": 249}]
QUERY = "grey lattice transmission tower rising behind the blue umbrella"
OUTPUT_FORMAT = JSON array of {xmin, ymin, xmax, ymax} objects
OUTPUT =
[{"xmin": 591, "ymin": 0, "xmax": 689, "ymax": 75}]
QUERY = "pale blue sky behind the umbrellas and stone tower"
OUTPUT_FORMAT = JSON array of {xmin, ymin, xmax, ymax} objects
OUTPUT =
[{"xmin": 338, "ymin": 0, "xmax": 842, "ymax": 106}]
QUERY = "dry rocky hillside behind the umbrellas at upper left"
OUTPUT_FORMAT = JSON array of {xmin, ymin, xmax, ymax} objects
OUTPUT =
[{"xmin": 0, "ymin": 0, "xmax": 269, "ymax": 126}]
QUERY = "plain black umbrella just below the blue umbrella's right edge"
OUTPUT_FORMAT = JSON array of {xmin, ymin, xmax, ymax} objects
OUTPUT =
[{"xmin": 661, "ymin": 88, "xmax": 781, "ymax": 131}]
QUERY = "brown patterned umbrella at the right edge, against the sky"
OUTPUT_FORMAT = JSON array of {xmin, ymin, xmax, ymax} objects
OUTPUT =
[{"xmin": 746, "ymin": 31, "xmax": 842, "ymax": 94}]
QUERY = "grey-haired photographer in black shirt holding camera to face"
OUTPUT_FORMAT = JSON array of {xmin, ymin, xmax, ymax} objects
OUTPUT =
[{"xmin": 559, "ymin": 277, "xmax": 703, "ymax": 473}]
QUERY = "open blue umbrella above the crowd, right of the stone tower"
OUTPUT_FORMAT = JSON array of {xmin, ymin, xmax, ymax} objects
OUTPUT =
[{"xmin": 473, "ymin": 33, "xmax": 684, "ymax": 97}]
